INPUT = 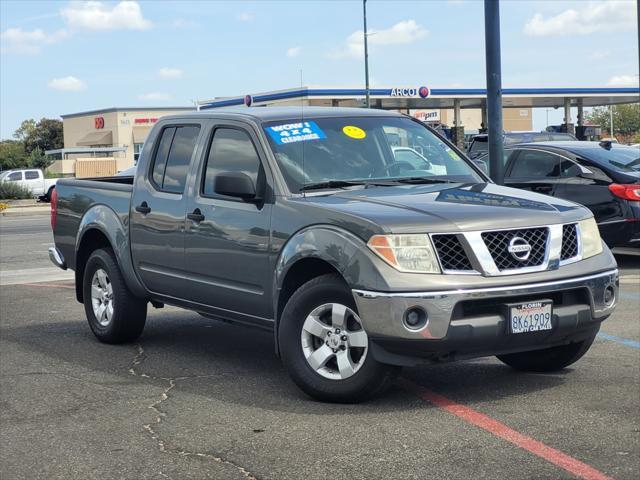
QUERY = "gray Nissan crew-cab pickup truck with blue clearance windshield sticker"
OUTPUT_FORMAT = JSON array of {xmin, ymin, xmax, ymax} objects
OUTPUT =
[{"xmin": 49, "ymin": 107, "xmax": 618, "ymax": 402}]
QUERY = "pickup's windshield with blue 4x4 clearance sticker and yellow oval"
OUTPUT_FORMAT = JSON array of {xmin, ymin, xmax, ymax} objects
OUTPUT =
[{"xmin": 264, "ymin": 117, "xmax": 484, "ymax": 193}]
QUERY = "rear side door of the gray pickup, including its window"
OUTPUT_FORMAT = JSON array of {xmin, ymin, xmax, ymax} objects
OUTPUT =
[{"xmin": 130, "ymin": 120, "xmax": 203, "ymax": 298}]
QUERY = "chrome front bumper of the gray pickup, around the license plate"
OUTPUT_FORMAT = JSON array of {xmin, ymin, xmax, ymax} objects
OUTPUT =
[{"xmin": 352, "ymin": 269, "xmax": 618, "ymax": 340}]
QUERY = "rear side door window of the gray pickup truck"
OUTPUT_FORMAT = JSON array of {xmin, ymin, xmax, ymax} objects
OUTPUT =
[{"xmin": 152, "ymin": 125, "xmax": 200, "ymax": 193}]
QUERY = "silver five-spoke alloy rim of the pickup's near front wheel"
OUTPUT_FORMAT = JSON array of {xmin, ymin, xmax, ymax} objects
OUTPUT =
[{"xmin": 301, "ymin": 303, "xmax": 369, "ymax": 380}]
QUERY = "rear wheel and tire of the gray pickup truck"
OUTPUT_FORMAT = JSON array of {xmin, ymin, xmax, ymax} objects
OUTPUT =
[{"xmin": 82, "ymin": 248, "xmax": 147, "ymax": 343}]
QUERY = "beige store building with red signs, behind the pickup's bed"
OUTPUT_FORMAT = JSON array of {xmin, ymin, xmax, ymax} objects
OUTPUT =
[{"xmin": 46, "ymin": 107, "xmax": 195, "ymax": 177}]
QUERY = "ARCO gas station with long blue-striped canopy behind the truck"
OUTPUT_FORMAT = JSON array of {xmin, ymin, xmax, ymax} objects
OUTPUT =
[{"xmin": 198, "ymin": 86, "xmax": 640, "ymax": 147}]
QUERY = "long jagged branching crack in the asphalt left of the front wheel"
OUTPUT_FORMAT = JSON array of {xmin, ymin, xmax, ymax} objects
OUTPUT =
[{"xmin": 129, "ymin": 343, "xmax": 258, "ymax": 480}]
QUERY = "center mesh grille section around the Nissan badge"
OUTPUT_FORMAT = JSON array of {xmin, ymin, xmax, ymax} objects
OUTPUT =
[{"xmin": 482, "ymin": 227, "xmax": 549, "ymax": 271}]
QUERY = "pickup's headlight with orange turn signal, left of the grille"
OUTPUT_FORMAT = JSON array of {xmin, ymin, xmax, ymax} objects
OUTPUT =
[{"xmin": 367, "ymin": 234, "xmax": 440, "ymax": 273}]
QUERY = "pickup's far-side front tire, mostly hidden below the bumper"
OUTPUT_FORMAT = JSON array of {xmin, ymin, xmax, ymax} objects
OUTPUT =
[{"xmin": 497, "ymin": 334, "xmax": 596, "ymax": 373}]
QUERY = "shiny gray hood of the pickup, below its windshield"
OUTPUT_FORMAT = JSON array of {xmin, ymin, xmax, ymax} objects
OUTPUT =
[{"xmin": 301, "ymin": 183, "xmax": 591, "ymax": 233}]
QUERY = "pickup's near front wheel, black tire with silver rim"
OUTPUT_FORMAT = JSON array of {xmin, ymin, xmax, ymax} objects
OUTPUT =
[{"xmin": 278, "ymin": 274, "xmax": 400, "ymax": 403}]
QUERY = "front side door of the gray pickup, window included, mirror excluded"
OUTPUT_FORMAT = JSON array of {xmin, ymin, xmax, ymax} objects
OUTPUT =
[{"xmin": 185, "ymin": 122, "xmax": 273, "ymax": 324}]
